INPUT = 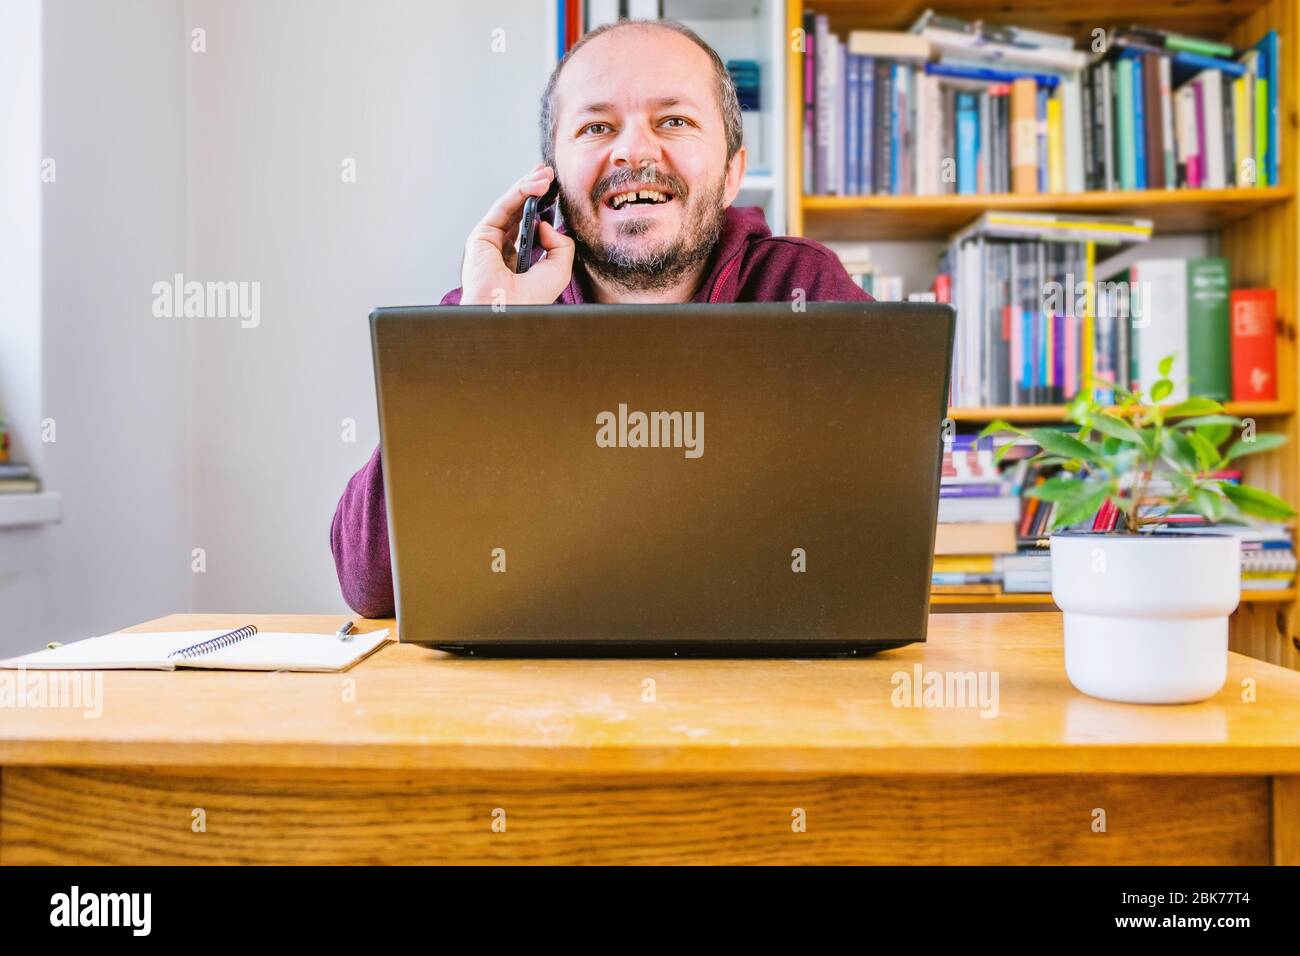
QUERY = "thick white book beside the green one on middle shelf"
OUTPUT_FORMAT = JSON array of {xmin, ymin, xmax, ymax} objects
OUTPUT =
[{"xmin": 1130, "ymin": 259, "xmax": 1187, "ymax": 403}]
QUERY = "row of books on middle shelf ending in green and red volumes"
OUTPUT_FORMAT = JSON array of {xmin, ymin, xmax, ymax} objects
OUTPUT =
[{"xmin": 933, "ymin": 211, "xmax": 1278, "ymax": 407}]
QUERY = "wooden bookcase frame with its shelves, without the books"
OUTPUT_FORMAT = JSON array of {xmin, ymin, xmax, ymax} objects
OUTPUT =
[{"xmin": 785, "ymin": 0, "xmax": 1300, "ymax": 669}]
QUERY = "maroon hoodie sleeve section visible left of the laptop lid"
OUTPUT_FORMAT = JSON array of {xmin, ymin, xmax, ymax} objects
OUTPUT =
[{"xmin": 330, "ymin": 446, "xmax": 394, "ymax": 618}]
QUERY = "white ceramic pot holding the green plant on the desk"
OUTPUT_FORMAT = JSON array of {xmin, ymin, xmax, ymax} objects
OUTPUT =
[{"xmin": 1052, "ymin": 532, "xmax": 1242, "ymax": 704}]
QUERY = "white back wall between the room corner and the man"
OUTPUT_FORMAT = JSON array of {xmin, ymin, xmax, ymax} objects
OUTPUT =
[{"xmin": 186, "ymin": 0, "xmax": 554, "ymax": 613}]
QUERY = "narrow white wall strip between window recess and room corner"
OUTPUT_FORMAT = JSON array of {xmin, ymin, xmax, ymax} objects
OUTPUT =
[{"xmin": 33, "ymin": 0, "xmax": 190, "ymax": 655}]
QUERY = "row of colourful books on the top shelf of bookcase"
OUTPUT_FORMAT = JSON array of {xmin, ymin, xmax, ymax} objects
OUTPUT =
[{"xmin": 803, "ymin": 10, "xmax": 1281, "ymax": 195}]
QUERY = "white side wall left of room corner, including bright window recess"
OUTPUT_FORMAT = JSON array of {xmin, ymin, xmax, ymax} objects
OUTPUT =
[{"xmin": 0, "ymin": 0, "xmax": 190, "ymax": 653}]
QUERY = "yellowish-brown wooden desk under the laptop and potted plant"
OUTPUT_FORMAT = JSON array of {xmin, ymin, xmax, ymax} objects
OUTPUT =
[{"xmin": 0, "ymin": 614, "xmax": 1300, "ymax": 865}]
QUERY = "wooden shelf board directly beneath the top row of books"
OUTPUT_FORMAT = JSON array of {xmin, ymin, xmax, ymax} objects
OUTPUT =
[{"xmin": 801, "ymin": 186, "xmax": 1295, "ymax": 241}]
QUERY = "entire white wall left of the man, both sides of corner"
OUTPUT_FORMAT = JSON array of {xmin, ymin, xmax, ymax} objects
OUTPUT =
[{"xmin": 0, "ymin": 0, "xmax": 566, "ymax": 654}]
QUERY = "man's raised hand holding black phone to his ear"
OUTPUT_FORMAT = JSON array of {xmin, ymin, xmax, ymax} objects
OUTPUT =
[{"xmin": 460, "ymin": 163, "xmax": 573, "ymax": 306}]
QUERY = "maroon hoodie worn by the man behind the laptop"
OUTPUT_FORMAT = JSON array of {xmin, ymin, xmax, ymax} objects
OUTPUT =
[{"xmin": 330, "ymin": 206, "xmax": 871, "ymax": 618}]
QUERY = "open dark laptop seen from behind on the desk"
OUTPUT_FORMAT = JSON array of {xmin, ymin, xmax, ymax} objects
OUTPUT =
[{"xmin": 371, "ymin": 302, "xmax": 954, "ymax": 657}]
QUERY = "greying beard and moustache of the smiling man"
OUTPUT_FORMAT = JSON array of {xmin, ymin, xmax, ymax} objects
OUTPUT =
[{"xmin": 559, "ymin": 167, "xmax": 727, "ymax": 291}]
